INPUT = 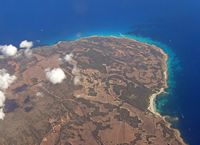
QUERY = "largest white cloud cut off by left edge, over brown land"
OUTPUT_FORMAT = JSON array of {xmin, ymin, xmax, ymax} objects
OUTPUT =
[{"xmin": 0, "ymin": 69, "xmax": 16, "ymax": 90}]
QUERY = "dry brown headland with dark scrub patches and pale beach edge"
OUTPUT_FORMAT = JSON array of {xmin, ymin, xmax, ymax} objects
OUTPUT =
[{"xmin": 0, "ymin": 36, "xmax": 185, "ymax": 145}]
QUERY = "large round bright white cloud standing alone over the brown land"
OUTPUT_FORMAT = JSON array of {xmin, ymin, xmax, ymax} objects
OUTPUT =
[{"xmin": 45, "ymin": 68, "xmax": 66, "ymax": 84}]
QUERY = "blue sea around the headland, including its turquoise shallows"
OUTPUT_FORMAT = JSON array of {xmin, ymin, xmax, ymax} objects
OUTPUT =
[{"xmin": 0, "ymin": 0, "xmax": 200, "ymax": 145}]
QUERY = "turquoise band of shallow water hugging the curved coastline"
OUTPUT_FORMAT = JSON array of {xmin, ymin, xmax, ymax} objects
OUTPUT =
[{"xmin": 63, "ymin": 32, "xmax": 189, "ymax": 142}]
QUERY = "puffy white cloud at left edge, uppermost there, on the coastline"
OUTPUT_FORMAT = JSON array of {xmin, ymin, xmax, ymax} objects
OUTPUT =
[{"xmin": 0, "ymin": 44, "xmax": 17, "ymax": 57}]
